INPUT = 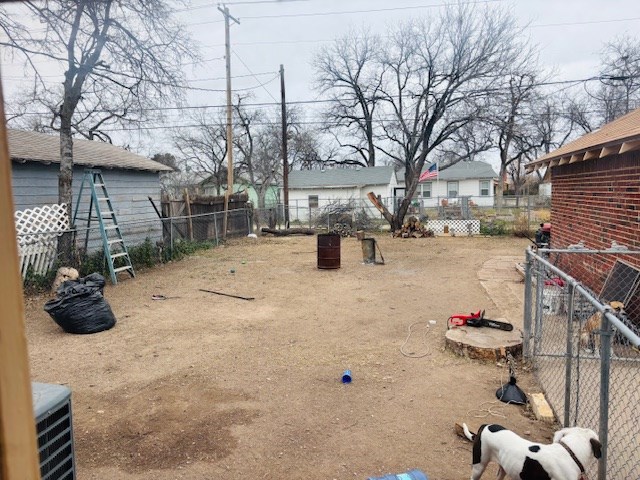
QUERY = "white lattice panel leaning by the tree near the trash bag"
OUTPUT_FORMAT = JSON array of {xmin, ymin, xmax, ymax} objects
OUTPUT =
[{"xmin": 14, "ymin": 204, "xmax": 69, "ymax": 279}]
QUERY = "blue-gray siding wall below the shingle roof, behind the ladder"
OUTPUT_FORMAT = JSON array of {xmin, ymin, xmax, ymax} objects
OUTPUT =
[{"xmin": 12, "ymin": 162, "xmax": 162, "ymax": 250}]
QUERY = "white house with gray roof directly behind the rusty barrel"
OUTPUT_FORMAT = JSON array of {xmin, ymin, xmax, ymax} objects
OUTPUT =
[{"xmin": 289, "ymin": 166, "xmax": 398, "ymax": 220}]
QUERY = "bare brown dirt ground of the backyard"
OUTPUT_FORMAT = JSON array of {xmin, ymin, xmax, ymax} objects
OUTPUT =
[{"xmin": 26, "ymin": 236, "xmax": 554, "ymax": 480}]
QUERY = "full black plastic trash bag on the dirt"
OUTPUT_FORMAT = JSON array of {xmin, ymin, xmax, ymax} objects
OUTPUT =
[{"xmin": 44, "ymin": 273, "xmax": 116, "ymax": 333}]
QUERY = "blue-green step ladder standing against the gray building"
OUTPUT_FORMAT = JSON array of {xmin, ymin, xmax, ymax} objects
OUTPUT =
[{"xmin": 73, "ymin": 169, "xmax": 136, "ymax": 285}]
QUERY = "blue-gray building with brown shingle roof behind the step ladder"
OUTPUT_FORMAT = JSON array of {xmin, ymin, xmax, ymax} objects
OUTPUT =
[{"xmin": 8, "ymin": 130, "xmax": 173, "ymax": 253}]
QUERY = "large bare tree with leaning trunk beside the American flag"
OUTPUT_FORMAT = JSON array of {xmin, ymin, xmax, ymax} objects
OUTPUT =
[{"xmin": 372, "ymin": 3, "xmax": 523, "ymax": 229}]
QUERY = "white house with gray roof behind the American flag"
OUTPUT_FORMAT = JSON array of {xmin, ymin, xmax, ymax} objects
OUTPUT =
[{"xmin": 395, "ymin": 161, "xmax": 498, "ymax": 207}]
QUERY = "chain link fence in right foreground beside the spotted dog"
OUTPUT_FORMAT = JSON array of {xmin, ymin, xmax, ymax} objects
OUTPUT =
[{"xmin": 523, "ymin": 245, "xmax": 640, "ymax": 480}]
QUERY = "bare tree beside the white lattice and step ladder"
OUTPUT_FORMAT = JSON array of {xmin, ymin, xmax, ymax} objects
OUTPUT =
[{"xmin": 0, "ymin": 0, "xmax": 195, "ymax": 260}]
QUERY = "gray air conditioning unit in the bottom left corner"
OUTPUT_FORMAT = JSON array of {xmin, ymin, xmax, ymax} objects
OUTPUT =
[{"xmin": 31, "ymin": 382, "xmax": 76, "ymax": 480}]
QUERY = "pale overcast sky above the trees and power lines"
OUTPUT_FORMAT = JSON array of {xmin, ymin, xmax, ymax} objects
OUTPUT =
[{"xmin": 3, "ymin": 0, "xmax": 640, "ymax": 153}]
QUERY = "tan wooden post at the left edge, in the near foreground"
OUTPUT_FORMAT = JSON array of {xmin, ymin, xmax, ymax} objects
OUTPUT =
[{"xmin": 0, "ymin": 75, "xmax": 40, "ymax": 480}]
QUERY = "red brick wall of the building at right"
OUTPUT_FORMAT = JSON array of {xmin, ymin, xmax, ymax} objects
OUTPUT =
[{"xmin": 551, "ymin": 152, "xmax": 640, "ymax": 294}]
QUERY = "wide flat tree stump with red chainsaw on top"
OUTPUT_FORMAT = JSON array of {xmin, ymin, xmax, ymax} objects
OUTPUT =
[{"xmin": 445, "ymin": 327, "xmax": 522, "ymax": 361}]
